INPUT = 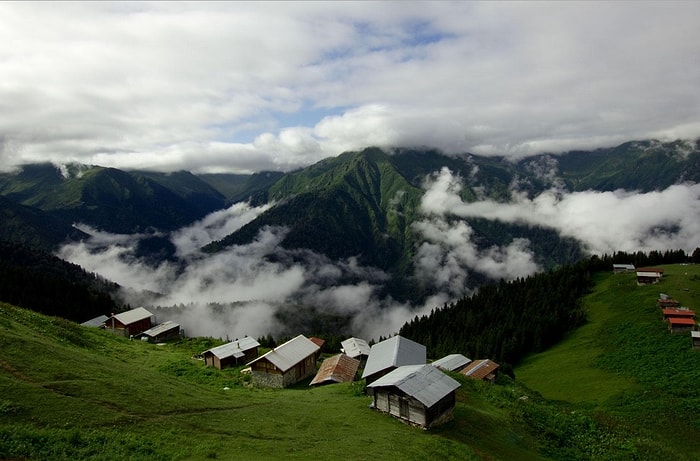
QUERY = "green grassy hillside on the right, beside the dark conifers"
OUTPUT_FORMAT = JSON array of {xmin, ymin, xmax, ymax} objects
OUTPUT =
[{"xmin": 515, "ymin": 265, "xmax": 700, "ymax": 459}]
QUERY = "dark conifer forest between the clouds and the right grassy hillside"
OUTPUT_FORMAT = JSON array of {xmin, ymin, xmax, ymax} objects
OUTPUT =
[{"xmin": 399, "ymin": 249, "xmax": 700, "ymax": 374}]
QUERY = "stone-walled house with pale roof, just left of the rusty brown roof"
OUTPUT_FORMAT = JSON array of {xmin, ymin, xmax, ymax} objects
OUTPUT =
[{"xmin": 248, "ymin": 335, "xmax": 320, "ymax": 387}]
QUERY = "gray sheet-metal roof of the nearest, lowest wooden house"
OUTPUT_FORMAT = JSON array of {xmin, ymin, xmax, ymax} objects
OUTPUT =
[{"xmin": 367, "ymin": 365, "xmax": 460, "ymax": 407}]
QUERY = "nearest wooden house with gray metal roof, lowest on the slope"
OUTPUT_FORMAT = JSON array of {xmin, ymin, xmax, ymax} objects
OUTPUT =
[{"xmin": 367, "ymin": 364, "xmax": 459, "ymax": 429}]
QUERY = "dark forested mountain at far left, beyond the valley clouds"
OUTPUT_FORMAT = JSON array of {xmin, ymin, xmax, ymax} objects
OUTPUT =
[{"xmin": 0, "ymin": 164, "xmax": 226, "ymax": 233}]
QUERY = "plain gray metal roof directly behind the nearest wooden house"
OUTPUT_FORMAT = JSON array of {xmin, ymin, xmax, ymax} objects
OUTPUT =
[{"xmin": 362, "ymin": 335, "xmax": 426, "ymax": 378}]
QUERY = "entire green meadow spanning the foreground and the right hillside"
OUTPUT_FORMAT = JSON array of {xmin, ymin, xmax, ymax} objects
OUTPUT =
[{"xmin": 0, "ymin": 266, "xmax": 700, "ymax": 460}]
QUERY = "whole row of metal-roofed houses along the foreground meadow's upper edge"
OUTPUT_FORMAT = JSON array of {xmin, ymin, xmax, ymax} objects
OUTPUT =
[{"xmin": 83, "ymin": 307, "xmax": 499, "ymax": 429}]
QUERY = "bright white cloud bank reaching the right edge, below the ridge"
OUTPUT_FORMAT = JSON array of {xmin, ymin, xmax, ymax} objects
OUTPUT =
[{"xmin": 422, "ymin": 169, "xmax": 700, "ymax": 254}]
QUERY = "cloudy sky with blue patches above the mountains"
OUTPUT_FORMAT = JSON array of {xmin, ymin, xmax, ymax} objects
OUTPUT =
[{"xmin": 0, "ymin": 1, "xmax": 700, "ymax": 173}]
